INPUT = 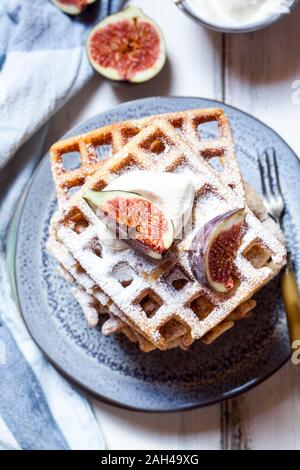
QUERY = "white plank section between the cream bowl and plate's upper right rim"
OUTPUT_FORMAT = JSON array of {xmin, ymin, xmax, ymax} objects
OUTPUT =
[{"xmin": 225, "ymin": 7, "xmax": 300, "ymax": 154}]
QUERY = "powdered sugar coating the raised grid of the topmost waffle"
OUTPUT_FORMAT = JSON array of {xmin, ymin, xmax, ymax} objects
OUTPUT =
[{"xmin": 51, "ymin": 120, "xmax": 286, "ymax": 349}]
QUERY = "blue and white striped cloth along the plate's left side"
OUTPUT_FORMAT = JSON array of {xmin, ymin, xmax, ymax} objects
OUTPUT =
[{"xmin": 0, "ymin": 0, "xmax": 124, "ymax": 450}]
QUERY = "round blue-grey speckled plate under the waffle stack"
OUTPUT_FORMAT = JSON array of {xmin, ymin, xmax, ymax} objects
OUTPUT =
[{"xmin": 15, "ymin": 98, "xmax": 300, "ymax": 411}]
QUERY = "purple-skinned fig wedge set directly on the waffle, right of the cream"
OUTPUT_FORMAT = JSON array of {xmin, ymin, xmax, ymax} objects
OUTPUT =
[{"xmin": 189, "ymin": 209, "xmax": 245, "ymax": 293}]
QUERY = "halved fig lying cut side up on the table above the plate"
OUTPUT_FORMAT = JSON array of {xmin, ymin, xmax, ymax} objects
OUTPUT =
[{"xmin": 87, "ymin": 6, "xmax": 166, "ymax": 83}]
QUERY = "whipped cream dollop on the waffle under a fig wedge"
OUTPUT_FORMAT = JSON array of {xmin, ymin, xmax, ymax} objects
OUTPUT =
[{"xmin": 91, "ymin": 170, "xmax": 195, "ymax": 250}]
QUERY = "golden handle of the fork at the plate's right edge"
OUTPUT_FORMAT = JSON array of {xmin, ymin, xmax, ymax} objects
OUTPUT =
[{"xmin": 281, "ymin": 263, "xmax": 300, "ymax": 346}]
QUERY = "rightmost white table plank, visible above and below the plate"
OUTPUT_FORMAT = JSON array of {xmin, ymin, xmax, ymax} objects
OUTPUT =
[{"xmin": 222, "ymin": 8, "xmax": 300, "ymax": 449}]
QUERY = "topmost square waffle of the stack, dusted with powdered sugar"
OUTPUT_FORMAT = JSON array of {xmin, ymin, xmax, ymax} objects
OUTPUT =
[{"xmin": 50, "ymin": 119, "xmax": 286, "ymax": 349}]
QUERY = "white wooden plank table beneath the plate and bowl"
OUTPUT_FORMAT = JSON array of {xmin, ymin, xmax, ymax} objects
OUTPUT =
[{"xmin": 44, "ymin": 0, "xmax": 300, "ymax": 450}]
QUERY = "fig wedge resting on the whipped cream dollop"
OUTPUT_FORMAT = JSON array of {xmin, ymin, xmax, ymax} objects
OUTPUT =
[{"xmin": 83, "ymin": 190, "xmax": 174, "ymax": 259}]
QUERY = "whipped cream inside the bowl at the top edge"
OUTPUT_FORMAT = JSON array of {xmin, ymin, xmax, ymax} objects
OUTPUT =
[{"xmin": 188, "ymin": 0, "xmax": 292, "ymax": 26}]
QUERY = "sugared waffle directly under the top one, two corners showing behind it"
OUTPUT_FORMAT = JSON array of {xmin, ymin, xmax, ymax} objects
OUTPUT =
[{"xmin": 50, "ymin": 108, "xmax": 245, "ymax": 206}]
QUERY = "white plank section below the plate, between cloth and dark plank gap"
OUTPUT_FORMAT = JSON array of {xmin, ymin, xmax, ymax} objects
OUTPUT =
[{"xmin": 89, "ymin": 402, "xmax": 220, "ymax": 450}]
